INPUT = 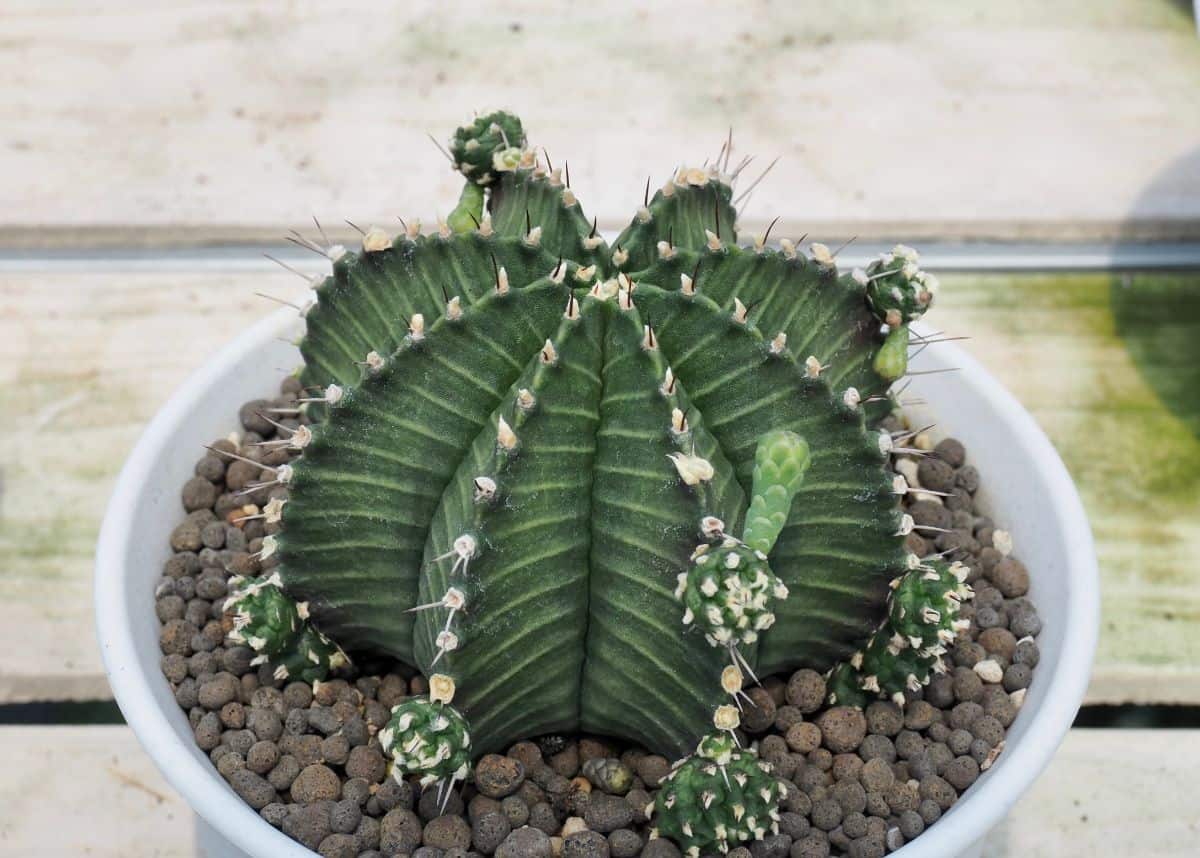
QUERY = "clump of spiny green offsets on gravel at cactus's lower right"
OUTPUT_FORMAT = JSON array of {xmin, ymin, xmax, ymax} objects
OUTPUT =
[{"xmin": 829, "ymin": 558, "xmax": 973, "ymax": 706}]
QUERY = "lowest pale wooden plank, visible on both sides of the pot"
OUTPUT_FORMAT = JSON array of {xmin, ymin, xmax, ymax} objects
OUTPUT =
[{"xmin": 0, "ymin": 727, "xmax": 1200, "ymax": 858}]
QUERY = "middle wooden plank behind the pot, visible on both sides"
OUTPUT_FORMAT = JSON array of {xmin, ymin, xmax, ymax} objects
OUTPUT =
[{"xmin": 0, "ymin": 270, "xmax": 1200, "ymax": 703}]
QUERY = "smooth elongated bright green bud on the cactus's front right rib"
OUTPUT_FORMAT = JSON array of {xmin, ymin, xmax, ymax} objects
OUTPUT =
[{"xmin": 742, "ymin": 431, "xmax": 812, "ymax": 554}]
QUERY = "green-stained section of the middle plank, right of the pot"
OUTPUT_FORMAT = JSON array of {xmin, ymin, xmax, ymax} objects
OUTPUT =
[{"xmin": 928, "ymin": 274, "xmax": 1200, "ymax": 703}]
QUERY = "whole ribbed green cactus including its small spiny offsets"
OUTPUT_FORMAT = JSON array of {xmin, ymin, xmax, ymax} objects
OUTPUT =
[{"xmin": 233, "ymin": 113, "xmax": 968, "ymax": 853}]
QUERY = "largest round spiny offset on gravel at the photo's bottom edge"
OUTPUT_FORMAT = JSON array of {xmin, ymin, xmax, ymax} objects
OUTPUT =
[{"xmin": 653, "ymin": 736, "xmax": 786, "ymax": 858}]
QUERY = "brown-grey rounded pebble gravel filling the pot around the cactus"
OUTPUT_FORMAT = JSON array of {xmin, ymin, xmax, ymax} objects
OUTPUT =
[{"xmin": 157, "ymin": 377, "xmax": 1042, "ymax": 858}]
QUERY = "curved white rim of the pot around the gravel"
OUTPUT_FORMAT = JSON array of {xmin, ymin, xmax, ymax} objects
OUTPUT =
[{"xmin": 95, "ymin": 308, "xmax": 1099, "ymax": 858}]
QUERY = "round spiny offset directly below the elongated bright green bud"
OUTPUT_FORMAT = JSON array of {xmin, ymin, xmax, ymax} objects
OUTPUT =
[{"xmin": 676, "ymin": 536, "xmax": 787, "ymax": 647}]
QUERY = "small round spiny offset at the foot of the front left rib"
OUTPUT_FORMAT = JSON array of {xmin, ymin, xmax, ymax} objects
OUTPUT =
[{"xmin": 379, "ymin": 697, "xmax": 470, "ymax": 786}]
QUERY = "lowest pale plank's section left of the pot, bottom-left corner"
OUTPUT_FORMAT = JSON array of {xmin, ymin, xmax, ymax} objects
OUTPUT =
[{"xmin": 0, "ymin": 726, "xmax": 193, "ymax": 858}]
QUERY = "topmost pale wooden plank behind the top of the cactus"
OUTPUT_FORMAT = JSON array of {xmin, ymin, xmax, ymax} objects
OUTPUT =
[{"xmin": 0, "ymin": 0, "xmax": 1200, "ymax": 246}]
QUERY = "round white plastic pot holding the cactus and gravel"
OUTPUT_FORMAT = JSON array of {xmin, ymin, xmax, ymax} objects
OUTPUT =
[{"xmin": 96, "ymin": 311, "xmax": 1099, "ymax": 858}]
